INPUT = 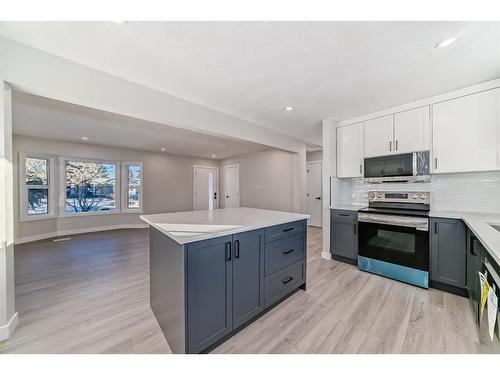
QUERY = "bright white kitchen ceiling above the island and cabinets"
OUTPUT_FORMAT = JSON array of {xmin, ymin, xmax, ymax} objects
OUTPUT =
[{"xmin": 0, "ymin": 22, "xmax": 500, "ymax": 144}]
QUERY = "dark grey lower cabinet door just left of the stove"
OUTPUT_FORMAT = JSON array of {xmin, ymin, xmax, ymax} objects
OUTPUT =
[{"xmin": 330, "ymin": 210, "xmax": 358, "ymax": 259}]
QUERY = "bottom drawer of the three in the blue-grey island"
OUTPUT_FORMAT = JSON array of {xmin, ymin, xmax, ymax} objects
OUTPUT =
[{"xmin": 264, "ymin": 259, "xmax": 305, "ymax": 308}]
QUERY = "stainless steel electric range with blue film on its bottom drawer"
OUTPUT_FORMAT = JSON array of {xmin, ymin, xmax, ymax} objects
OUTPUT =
[{"xmin": 358, "ymin": 191, "xmax": 430, "ymax": 288}]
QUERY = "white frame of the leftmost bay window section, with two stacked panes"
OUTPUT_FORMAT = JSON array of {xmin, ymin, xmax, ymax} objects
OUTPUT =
[{"xmin": 18, "ymin": 151, "xmax": 57, "ymax": 222}]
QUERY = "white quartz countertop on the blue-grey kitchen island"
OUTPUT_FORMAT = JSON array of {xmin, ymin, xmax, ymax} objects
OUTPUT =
[{"xmin": 141, "ymin": 207, "xmax": 310, "ymax": 244}]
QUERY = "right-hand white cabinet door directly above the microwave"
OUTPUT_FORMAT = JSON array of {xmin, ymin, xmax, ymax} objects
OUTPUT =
[{"xmin": 394, "ymin": 106, "xmax": 430, "ymax": 153}]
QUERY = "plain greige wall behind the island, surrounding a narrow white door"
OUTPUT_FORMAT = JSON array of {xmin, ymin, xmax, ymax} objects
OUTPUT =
[{"xmin": 220, "ymin": 150, "xmax": 305, "ymax": 212}]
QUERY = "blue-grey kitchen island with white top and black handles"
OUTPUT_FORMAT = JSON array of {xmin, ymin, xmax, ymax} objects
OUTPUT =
[{"xmin": 141, "ymin": 207, "xmax": 309, "ymax": 353}]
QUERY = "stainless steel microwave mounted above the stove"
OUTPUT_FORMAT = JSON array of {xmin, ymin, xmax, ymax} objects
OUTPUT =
[{"xmin": 364, "ymin": 151, "xmax": 431, "ymax": 183}]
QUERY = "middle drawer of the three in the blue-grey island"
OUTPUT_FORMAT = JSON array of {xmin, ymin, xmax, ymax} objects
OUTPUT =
[{"xmin": 265, "ymin": 233, "xmax": 305, "ymax": 275}]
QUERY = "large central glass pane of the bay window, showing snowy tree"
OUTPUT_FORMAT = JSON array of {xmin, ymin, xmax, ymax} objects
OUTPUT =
[{"xmin": 65, "ymin": 161, "xmax": 116, "ymax": 213}]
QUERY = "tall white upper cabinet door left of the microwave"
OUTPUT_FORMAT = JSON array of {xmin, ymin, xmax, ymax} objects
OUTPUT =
[{"xmin": 337, "ymin": 122, "xmax": 363, "ymax": 178}]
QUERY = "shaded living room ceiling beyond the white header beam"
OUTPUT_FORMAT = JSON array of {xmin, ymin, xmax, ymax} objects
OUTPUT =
[{"xmin": 12, "ymin": 91, "xmax": 267, "ymax": 160}]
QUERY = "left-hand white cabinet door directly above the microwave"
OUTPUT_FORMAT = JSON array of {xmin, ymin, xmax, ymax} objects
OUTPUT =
[{"xmin": 365, "ymin": 115, "xmax": 394, "ymax": 158}]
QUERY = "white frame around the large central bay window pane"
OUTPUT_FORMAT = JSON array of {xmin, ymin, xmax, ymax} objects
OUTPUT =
[{"xmin": 59, "ymin": 156, "xmax": 122, "ymax": 218}]
